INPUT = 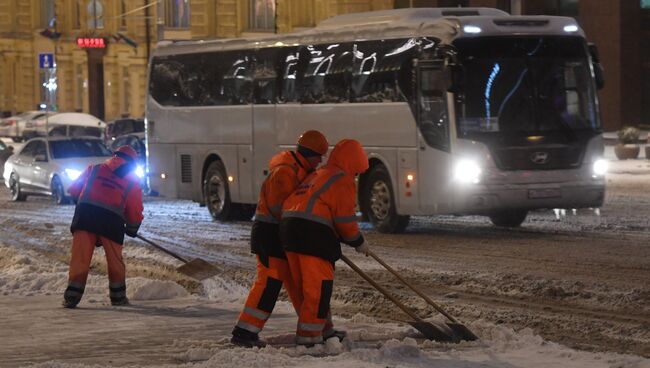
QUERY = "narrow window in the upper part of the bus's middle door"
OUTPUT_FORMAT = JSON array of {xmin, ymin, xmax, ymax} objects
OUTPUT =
[{"xmin": 253, "ymin": 48, "xmax": 280, "ymax": 104}]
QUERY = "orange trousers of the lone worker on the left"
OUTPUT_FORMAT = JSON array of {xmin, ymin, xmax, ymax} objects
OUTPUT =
[{"xmin": 64, "ymin": 230, "xmax": 126, "ymax": 302}]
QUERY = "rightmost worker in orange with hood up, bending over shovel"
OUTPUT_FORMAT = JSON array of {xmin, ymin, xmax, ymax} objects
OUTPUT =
[{"xmin": 280, "ymin": 139, "xmax": 368, "ymax": 346}]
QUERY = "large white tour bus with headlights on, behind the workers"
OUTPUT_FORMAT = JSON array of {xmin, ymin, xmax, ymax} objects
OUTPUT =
[{"xmin": 146, "ymin": 8, "xmax": 606, "ymax": 232}]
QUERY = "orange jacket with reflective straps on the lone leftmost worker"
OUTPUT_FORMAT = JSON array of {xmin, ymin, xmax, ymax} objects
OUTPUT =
[{"xmin": 68, "ymin": 157, "xmax": 144, "ymax": 244}]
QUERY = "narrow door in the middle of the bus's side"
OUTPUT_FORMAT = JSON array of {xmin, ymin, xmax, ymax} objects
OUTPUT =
[{"xmin": 252, "ymin": 48, "xmax": 281, "ymax": 199}]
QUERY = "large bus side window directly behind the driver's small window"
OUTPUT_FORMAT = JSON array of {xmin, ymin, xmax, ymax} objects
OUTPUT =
[{"xmin": 352, "ymin": 39, "xmax": 410, "ymax": 102}]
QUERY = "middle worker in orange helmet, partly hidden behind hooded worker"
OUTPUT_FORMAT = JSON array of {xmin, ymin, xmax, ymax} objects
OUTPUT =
[{"xmin": 231, "ymin": 130, "xmax": 328, "ymax": 347}]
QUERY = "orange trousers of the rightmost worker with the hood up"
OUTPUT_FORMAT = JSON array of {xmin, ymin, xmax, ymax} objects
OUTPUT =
[{"xmin": 286, "ymin": 252, "xmax": 334, "ymax": 345}]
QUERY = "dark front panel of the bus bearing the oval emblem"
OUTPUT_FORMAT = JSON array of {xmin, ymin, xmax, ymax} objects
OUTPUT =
[{"xmin": 493, "ymin": 145, "xmax": 583, "ymax": 170}]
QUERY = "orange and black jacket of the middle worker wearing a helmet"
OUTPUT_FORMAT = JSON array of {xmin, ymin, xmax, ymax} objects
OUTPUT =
[{"xmin": 251, "ymin": 151, "xmax": 313, "ymax": 263}]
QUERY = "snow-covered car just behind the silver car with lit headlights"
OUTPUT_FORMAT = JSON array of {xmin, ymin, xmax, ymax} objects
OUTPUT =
[{"xmin": 24, "ymin": 112, "xmax": 106, "ymax": 139}]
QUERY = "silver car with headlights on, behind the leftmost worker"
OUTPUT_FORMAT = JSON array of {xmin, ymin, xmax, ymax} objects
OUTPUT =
[{"xmin": 3, "ymin": 137, "xmax": 112, "ymax": 204}]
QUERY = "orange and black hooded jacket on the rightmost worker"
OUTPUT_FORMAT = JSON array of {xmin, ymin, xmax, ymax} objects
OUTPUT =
[{"xmin": 280, "ymin": 140, "xmax": 368, "ymax": 263}]
